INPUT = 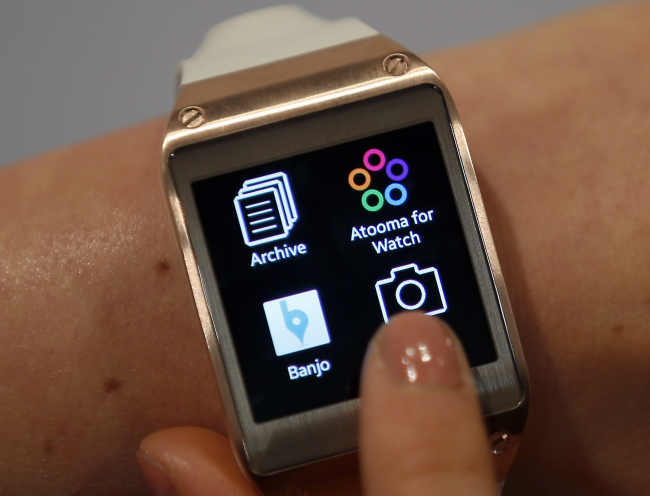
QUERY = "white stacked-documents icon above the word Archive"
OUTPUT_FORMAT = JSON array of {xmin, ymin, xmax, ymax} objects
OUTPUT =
[{"xmin": 234, "ymin": 172, "xmax": 298, "ymax": 246}]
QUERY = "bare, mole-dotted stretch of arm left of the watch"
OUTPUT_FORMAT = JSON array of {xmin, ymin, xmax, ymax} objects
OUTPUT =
[{"xmin": 0, "ymin": 120, "xmax": 223, "ymax": 495}]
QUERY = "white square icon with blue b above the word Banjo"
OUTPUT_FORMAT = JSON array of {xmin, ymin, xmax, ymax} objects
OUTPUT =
[{"xmin": 264, "ymin": 289, "xmax": 330, "ymax": 356}]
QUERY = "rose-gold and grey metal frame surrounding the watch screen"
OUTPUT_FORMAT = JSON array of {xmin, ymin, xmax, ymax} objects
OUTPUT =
[{"xmin": 163, "ymin": 36, "xmax": 528, "ymax": 475}]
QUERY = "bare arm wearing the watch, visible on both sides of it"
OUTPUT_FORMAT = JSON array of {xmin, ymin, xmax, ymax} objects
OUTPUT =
[{"xmin": 0, "ymin": 3, "xmax": 650, "ymax": 496}]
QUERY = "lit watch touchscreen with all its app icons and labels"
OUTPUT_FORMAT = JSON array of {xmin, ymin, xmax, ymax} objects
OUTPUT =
[{"xmin": 192, "ymin": 122, "xmax": 496, "ymax": 423}]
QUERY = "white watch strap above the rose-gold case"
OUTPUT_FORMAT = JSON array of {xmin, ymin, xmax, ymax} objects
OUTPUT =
[{"xmin": 179, "ymin": 5, "xmax": 377, "ymax": 84}]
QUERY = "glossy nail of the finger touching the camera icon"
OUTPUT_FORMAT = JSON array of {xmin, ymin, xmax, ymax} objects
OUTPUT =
[{"xmin": 378, "ymin": 314, "xmax": 462, "ymax": 388}]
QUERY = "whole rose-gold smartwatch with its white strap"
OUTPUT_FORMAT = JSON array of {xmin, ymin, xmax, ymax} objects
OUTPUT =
[{"xmin": 162, "ymin": 5, "xmax": 528, "ymax": 494}]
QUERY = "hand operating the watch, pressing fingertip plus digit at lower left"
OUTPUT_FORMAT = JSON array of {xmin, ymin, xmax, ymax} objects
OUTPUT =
[{"xmin": 138, "ymin": 313, "xmax": 496, "ymax": 496}]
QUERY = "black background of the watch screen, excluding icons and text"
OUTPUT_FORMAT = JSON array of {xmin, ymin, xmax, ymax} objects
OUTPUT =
[{"xmin": 192, "ymin": 123, "xmax": 496, "ymax": 422}]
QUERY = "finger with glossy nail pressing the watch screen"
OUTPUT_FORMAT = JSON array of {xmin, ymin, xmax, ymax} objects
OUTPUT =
[{"xmin": 360, "ymin": 312, "xmax": 496, "ymax": 496}]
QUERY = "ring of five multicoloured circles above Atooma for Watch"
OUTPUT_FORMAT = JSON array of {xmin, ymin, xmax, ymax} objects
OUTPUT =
[{"xmin": 348, "ymin": 148, "xmax": 409, "ymax": 212}]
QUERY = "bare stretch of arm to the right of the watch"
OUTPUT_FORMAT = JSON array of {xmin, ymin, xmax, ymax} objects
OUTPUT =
[{"xmin": 432, "ymin": 2, "xmax": 650, "ymax": 494}]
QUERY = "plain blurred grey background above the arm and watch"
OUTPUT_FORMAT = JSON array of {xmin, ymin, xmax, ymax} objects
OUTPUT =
[{"xmin": 0, "ymin": 0, "xmax": 598, "ymax": 165}]
